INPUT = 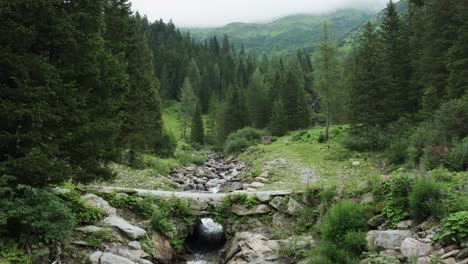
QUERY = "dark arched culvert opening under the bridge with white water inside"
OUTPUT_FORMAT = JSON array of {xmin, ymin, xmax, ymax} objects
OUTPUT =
[{"xmin": 185, "ymin": 218, "xmax": 226, "ymax": 264}]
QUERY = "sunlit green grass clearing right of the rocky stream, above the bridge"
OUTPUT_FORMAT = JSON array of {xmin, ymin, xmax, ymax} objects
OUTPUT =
[{"xmin": 240, "ymin": 127, "xmax": 381, "ymax": 193}]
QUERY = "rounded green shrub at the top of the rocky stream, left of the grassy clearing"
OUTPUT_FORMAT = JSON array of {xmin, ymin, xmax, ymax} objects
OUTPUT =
[{"xmin": 224, "ymin": 127, "xmax": 267, "ymax": 154}]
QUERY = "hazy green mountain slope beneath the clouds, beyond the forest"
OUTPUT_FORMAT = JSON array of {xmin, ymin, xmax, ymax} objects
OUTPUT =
[{"xmin": 185, "ymin": 9, "xmax": 372, "ymax": 53}]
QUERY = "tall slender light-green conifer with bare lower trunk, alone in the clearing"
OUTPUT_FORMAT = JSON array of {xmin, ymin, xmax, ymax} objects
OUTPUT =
[{"xmin": 315, "ymin": 22, "xmax": 338, "ymax": 142}]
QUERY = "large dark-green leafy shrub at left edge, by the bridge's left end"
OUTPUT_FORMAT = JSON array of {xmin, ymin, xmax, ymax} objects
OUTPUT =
[{"xmin": 0, "ymin": 186, "xmax": 76, "ymax": 243}]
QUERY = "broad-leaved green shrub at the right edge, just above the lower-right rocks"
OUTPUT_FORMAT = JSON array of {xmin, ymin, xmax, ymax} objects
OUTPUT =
[{"xmin": 436, "ymin": 211, "xmax": 468, "ymax": 243}]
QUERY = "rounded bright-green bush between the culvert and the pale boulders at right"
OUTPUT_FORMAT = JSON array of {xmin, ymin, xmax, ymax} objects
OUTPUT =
[{"xmin": 321, "ymin": 201, "xmax": 366, "ymax": 245}]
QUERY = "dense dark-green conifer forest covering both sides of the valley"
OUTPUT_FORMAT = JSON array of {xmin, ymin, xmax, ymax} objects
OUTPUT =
[{"xmin": 0, "ymin": 0, "xmax": 468, "ymax": 263}]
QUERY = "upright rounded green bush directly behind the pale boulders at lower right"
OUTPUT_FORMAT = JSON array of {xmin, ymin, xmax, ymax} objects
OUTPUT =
[{"xmin": 409, "ymin": 177, "xmax": 444, "ymax": 221}]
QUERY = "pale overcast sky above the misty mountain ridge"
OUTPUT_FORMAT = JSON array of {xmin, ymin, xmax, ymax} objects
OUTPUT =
[{"xmin": 131, "ymin": 0, "xmax": 388, "ymax": 27}]
